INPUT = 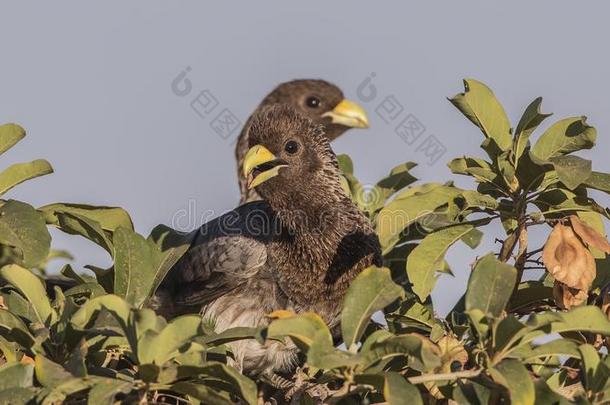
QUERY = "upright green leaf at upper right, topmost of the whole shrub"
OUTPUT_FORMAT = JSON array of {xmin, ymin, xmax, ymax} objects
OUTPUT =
[{"xmin": 449, "ymin": 79, "xmax": 512, "ymax": 154}]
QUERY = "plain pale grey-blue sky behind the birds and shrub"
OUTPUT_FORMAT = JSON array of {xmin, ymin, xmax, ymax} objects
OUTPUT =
[{"xmin": 0, "ymin": 0, "xmax": 610, "ymax": 313}]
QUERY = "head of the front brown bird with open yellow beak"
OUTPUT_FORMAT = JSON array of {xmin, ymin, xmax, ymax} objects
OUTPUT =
[{"xmin": 243, "ymin": 104, "xmax": 345, "ymax": 206}]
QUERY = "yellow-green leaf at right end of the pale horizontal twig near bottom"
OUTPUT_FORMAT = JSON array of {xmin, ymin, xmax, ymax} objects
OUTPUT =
[{"xmin": 489, "ymin": 359, "xmax": 536, "ymax": 405}]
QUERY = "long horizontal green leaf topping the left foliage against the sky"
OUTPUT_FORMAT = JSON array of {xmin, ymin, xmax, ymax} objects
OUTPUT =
[{"xmin": 39, "ymin": 203, "xmax": 133, "ymax": 232}]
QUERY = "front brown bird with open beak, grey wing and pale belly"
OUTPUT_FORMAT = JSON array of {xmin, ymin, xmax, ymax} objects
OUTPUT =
[{"xmin": 154, "ymin": 104, "xmax": 382, "ymax": 381}]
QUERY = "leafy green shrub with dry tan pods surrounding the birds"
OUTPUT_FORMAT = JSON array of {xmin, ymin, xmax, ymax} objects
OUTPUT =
[{"xmin": 0, "ymin": 80, "xmax": 610, "ymax": 404}]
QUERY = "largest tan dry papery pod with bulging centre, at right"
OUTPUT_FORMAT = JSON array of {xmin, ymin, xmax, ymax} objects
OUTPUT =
[{"xmin": 542, "ymin": 223, "xmax": 596, "ymax": 293}]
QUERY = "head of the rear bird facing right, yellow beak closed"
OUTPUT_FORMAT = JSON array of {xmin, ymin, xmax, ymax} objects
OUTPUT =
[{"xmin": 262, "ymin": 79, "xmax": 369, "ymax": 141}]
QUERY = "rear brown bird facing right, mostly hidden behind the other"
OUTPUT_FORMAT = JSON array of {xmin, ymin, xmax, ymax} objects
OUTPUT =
[{"xmin": 235, "ymin": 79, "xmax": 369, "ymax": 203}]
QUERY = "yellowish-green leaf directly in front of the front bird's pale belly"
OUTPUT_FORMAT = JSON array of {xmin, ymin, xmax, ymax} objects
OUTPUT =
[{"xmin": 267, "ymin": 312, "xmax": 333, "ymax": 352}]
